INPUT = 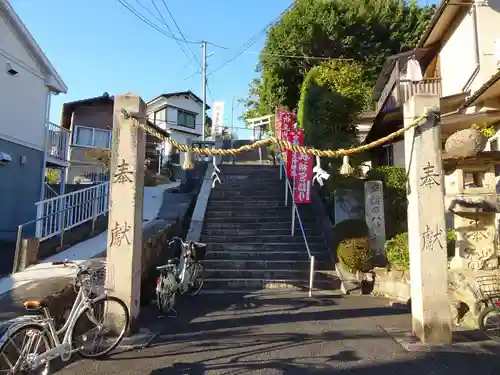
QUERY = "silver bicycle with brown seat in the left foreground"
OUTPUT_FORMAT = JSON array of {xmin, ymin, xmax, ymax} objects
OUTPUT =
[{"xmin": 0, "ymin": 261, "xmax": 130, "ymax": 375}]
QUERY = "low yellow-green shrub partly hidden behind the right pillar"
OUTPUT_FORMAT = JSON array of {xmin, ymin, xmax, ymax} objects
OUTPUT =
[{"xmin": 385, "ymin": 229, "xmax": 456, "ymax": 271}]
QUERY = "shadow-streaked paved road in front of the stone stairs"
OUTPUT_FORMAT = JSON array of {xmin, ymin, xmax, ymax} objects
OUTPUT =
[{"xmin": 51, "ymin": 291, "xmax": 500, "ymax": 375}]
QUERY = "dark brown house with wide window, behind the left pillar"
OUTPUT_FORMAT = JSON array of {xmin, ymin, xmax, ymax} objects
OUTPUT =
[{"xmin": 61, "ymin": 93, "xmax": 169, "ymax": 184}]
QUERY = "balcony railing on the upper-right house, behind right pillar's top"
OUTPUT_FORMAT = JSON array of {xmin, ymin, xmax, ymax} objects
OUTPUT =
[{"xmin": 377, "ymin": 76, "xmax": 442, "ymax": 112}]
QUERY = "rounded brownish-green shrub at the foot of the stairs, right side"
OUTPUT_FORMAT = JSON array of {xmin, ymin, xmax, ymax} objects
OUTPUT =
[{"xmin": 333, "ymin": 219, "xmax": 373, "ymax": 272}]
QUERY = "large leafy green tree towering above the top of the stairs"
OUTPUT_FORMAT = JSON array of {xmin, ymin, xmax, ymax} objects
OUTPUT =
[{"xmin": 247, "ymin": 0, "xmax": 435, "ymax": 116}]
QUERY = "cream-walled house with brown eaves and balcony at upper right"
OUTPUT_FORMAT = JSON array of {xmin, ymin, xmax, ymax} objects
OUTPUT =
[{"xmin": 365, "ymin": 0, "xmax": 500, "ymax": 166}]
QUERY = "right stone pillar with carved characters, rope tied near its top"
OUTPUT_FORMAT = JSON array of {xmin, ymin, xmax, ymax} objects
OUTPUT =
[{"xmin": 404, "ymin": 94, "xmax": 451, "ymax": 344}]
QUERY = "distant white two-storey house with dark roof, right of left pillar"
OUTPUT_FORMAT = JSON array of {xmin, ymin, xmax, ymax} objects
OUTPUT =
[{"xmin": 147, "ymin": 91, "xmax": 210, "ymax": 169}]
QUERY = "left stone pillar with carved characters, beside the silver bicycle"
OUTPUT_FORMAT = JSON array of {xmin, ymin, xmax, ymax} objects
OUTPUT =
[{"xmin": 106, "ymin": 94, "xmax": 146, "ymax": 333}]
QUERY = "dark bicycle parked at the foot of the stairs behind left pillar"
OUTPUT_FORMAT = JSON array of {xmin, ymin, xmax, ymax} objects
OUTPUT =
[{"xmin": 156, "ymin": 237, "xmax": 207, "ymax": 314}]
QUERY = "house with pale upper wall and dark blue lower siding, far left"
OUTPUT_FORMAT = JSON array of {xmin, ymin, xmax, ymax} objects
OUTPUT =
[{"xmin": 0, "ymin": 0, "xmax": 68, "ymax": 240}]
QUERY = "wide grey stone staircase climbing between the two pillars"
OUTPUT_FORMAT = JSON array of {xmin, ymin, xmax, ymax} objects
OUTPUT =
[{"xmin": 201, "ymin": 165, "xmax": 339, "ymax": 293}]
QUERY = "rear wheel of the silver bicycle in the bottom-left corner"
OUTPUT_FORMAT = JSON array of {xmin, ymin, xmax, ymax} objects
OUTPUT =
[{"xmin": 0, "ymin": 324, "xmax": 52, "ymax": 375}]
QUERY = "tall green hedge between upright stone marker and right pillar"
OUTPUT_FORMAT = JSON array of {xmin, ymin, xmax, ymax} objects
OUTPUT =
[{"xmin": 366, "ymin": 166, "xmax": 408, "ymax": 238}]
